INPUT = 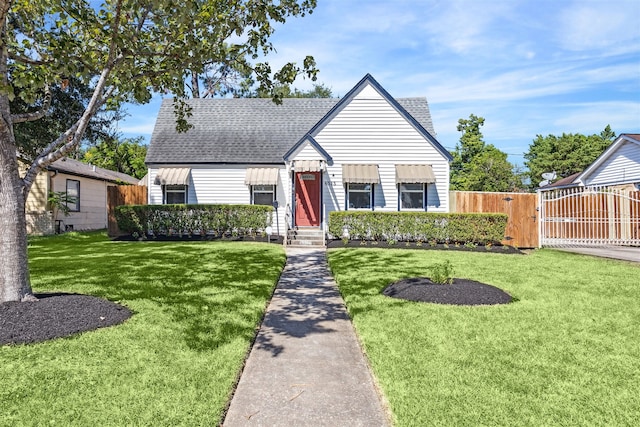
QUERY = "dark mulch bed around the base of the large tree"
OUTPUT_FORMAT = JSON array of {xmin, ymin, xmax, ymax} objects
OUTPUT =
[{"xmin": 0, "ymin": 293, "xmax": 132, "ymax": 345}]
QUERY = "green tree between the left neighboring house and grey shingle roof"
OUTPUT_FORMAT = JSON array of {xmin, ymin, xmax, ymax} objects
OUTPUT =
[{"xmin": 81, "ymin": 135, "xmax": 147, "ymax": 178}]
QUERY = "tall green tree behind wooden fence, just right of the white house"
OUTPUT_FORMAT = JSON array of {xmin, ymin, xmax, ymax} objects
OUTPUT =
[{"xmin": 451, "ymin": 114, "xmax": 522, "ymax": 191}]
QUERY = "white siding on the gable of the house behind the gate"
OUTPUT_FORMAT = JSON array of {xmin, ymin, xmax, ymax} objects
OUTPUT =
[{"xmin": 584, "ymin": 141, "xmax": 640, "ymax": 186}]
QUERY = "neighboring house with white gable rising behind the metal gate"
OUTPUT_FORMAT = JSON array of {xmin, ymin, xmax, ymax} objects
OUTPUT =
[{"xmin": 540, "ymin": 133, "xmax": 640, "ymax": 191}]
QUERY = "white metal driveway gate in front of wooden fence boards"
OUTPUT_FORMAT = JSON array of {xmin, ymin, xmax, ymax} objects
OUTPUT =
[{"xmin": 538, "ymin": 187, "xmax": 640, "ymax": 247}]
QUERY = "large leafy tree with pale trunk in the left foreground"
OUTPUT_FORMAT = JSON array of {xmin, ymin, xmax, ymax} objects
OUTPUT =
[{"xmin": 0, "ymin": 0, "xmax": 317, "ymax": 302}]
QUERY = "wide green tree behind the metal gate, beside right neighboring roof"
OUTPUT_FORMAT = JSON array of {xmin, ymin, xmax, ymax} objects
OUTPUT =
[{"xmin": 524, "ymin": 125, "xmax": 616, "ymax": 189}]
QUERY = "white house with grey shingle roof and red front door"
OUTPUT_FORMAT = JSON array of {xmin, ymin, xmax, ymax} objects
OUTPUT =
[{"xmin": 146, "ymin": 75, "xmax": 452, "ymax": 239}]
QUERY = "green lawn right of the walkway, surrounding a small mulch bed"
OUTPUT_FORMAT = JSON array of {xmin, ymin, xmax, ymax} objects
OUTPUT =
[{"xmin": 328, "ymin": 249, "xmax": 640, "ymax": 426}]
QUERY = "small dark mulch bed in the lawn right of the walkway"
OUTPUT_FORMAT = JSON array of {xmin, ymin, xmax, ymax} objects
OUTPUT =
[{"xmin": 382, "ymin": 277, "xmax": 512, "ymax": 305}]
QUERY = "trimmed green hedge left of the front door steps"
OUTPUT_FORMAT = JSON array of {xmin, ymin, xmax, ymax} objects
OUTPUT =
[{"xmin": 116, "ymin": 205, "xmax": 273, "ymax": 237}]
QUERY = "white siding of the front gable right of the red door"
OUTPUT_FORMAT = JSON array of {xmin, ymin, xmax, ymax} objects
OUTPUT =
[{"xmin": 315, "ymin": 86, "xmax": 449, "ymax": 221}]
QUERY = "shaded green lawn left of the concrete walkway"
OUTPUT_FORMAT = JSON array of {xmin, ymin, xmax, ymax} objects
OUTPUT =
[{"xmin": 0, "ymin": 233, "xmax": 285, "ymax": 426}]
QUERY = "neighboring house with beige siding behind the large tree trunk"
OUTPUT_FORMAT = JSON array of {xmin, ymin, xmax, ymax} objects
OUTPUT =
[{"xmin": 26, "ymin": 158, "xmax": 139, "ymax": 234}]
